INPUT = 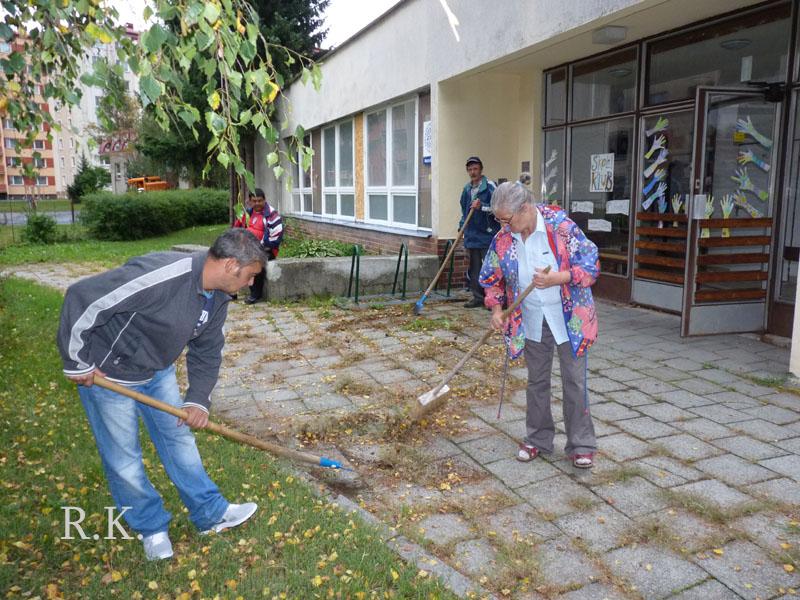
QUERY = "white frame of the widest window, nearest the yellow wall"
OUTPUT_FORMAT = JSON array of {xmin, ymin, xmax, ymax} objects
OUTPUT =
[{"xmin": 363, "ymin": 95, "xmax": 420, "ymax": 230}]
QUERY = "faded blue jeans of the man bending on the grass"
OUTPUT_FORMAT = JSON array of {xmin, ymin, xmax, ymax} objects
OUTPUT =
[{"xmin": 78, "ymin": 366, "xmax": 228, "ymax": 537}]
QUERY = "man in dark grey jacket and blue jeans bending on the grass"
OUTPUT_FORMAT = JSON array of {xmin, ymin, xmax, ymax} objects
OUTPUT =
[{"xmin": 57, "ymin": 229, "xmax": 266, "ymax": 560}]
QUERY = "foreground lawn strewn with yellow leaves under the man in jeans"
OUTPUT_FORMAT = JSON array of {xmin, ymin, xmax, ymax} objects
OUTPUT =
[{"xmin": 0, "ymin": 278, "xmax": 452, "ymax": 599}]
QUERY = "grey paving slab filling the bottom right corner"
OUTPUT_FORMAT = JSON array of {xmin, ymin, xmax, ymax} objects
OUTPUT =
[{"xmin": 696, "ymin": 541, "xmax": 800, "ymax": 600}]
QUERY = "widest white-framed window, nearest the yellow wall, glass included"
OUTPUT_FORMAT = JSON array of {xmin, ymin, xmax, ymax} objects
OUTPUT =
[{"xmin": 365, "ymin": 99, "xmax": 419, "ymax": 227}]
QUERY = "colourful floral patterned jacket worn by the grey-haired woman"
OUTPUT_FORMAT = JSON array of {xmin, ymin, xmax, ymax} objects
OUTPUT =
[{"xmin": 480, "ymin": 204, "xmax": 600, "ymax": 358}]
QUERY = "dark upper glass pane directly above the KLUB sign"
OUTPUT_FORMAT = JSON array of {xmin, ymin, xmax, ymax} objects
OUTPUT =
[{"xmin": 570, "ymin": 48, "xmax": 637, "ymax": 121}]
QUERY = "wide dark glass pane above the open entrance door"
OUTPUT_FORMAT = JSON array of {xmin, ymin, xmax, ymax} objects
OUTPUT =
[{"xmin": 645, "ymin": 2, "xmax": 791, "ymax": 104}]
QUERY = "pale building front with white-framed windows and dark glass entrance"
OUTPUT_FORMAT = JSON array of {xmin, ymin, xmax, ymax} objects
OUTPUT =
[{"xmin": 257, "ymin": 0, "xmax": 800, "ymax": 372}]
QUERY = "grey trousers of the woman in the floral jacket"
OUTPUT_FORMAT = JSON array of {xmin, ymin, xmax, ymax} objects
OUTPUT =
[{"xmin": 525, "ymin": 320, "xmax": 597, "ymax": 456}]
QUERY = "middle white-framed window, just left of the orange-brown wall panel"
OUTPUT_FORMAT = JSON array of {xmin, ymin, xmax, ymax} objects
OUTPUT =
[{"xmin": 322, "ymin": 120, "xmax": 356, "ymax": 219}]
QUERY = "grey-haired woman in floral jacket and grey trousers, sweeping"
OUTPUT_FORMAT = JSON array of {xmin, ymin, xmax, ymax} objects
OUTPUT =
[{"xmin": 480, "ymin": 182, "xmax": 600, "ymax": 469}]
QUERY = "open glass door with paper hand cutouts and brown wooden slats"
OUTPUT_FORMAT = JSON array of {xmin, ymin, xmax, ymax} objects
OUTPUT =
[{"xmin": 681, "ymin": 87, "xmax": 780, "ymax": 335}]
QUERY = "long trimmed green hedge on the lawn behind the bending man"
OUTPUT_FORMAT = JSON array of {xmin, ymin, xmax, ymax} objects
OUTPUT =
[{"xmin": 81, "ymin": 188, "xmax": 229, "ymax": 241}]
